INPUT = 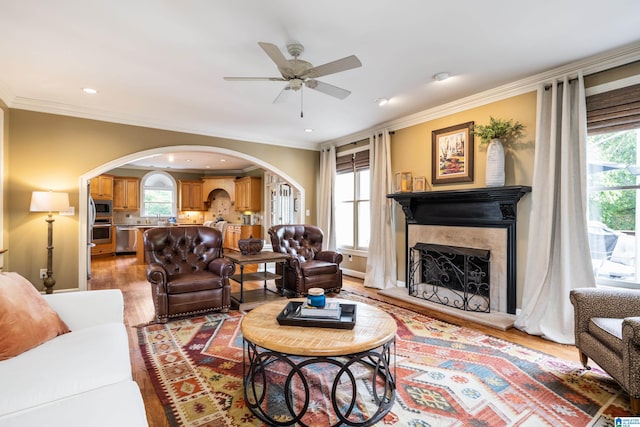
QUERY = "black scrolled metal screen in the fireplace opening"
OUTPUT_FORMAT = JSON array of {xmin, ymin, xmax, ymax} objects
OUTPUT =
[{"xmin": 409, "ymin": 243, "xmax": 491, "ymax": 313}]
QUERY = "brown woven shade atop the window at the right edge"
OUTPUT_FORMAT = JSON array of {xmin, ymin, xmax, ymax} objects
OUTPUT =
[{"xmin": 587, "ymin": 84, "xmax": 640, "ymax": 134}]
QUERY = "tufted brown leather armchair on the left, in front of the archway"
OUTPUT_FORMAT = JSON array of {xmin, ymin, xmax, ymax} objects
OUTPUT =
[{"xmin": 144, "ymin": 226, "xmax": 235, "ymax": 323}]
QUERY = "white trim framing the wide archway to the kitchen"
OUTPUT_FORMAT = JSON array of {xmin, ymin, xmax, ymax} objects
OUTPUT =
[{"xmin": 78, "ymin": 145, "xmax": 306, "ymax": 291}]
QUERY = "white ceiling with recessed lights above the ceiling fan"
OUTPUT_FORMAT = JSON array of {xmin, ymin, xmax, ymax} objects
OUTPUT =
[{"xmin": 0, "ymin": 0, "xmax": 640, "ymax": 172}]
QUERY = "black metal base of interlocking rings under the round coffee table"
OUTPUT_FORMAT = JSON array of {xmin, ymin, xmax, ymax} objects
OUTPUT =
[{"xmin": 243, "ymin": 339, "xmax": 396, "ymax": 427}]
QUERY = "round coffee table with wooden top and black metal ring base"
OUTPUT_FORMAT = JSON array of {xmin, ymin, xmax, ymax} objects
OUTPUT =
[{"xmin": 241, "ymin": 298, "xmax": 397, "ymax": 426}]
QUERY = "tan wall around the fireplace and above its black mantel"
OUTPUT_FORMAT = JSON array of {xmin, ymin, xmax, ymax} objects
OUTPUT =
[{"xmin": 391, "ymin": 92, "xmax": 536, "ymax": 307}]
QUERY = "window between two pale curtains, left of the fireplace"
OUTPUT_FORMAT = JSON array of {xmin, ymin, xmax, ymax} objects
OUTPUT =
[{"xmin": 335, "ymin": 149, "xmax": 371, "ymax": 251}]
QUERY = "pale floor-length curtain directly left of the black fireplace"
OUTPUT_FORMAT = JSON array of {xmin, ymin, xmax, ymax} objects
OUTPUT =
[{"xmin": 364, "ymin": 129, "xmax": 397, "ymax": 289}]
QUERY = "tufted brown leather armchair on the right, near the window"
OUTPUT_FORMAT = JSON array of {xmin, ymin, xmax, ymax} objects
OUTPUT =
[{"xmin": 268, "ymin": 224, "xmax": 342, "ymax": 296}]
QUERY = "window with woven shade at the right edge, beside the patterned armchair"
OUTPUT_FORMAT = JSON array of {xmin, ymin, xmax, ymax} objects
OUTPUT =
[{"xmin": 587, "ymin": 81, "xmax": 640, "ymax": 288}]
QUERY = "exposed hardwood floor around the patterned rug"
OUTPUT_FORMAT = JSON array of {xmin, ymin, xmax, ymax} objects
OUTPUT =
[{"xmin": 89, "ymin": 255, "xmax": 579, "ymax": 427}]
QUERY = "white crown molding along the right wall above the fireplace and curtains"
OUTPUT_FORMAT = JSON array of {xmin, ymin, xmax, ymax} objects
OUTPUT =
[{"xmin": 319, "ymin": 42, "xmax": 640, "ymax": 149}]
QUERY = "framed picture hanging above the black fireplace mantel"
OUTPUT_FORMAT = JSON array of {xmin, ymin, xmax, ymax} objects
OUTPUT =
[{"xmin": 431, "ymin": 122, "xmax": 473, "ymax": 185}]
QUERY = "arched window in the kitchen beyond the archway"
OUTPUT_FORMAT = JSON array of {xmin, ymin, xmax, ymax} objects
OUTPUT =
[{"xmin": 142, "ymin": 172, "xmax": 176, "ymax": 217}]
